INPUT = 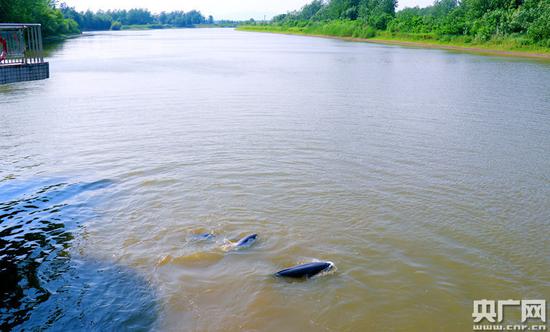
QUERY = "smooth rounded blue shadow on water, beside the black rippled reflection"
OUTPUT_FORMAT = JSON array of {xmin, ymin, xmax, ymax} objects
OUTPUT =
[{"xmin": 14, "ymin": 257, "xmax": 158, "ymax": 331}]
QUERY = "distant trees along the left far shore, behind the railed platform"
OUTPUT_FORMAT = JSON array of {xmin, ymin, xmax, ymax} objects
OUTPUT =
[{"xmin": 0, "ymin": 0, "xmax": 226, "ymax": 36}]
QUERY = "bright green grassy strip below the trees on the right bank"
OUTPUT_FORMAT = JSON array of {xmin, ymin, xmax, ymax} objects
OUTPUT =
[{"xmin": 238, "ymin": 21, "xmax": 550, "ymax": 59}]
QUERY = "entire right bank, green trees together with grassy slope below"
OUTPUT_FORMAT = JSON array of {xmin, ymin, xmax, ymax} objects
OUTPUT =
[{"xmin": 239, "ymin": 0, "xmax": 550, "ymax": 55}]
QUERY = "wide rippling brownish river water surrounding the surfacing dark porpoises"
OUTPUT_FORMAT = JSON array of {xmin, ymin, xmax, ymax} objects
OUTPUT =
[{"xmin": 0, "ymin": 29, "xmax": 550, "ymax": 331}]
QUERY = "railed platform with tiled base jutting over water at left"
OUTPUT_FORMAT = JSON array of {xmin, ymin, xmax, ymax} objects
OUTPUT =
[{"xmin": 0, "ymin": 23, "xmax": 50, "ymax": 84}]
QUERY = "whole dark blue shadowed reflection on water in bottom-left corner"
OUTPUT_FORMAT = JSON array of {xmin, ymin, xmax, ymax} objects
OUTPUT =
[{"xmin": 0, "ymin": 179, "xmax": 155, "ymax": 330}]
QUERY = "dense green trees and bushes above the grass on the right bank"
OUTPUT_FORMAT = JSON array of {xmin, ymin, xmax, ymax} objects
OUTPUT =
[{"xmin": 260, "ymin": 0, "xmax": 550, "ymax": 47}]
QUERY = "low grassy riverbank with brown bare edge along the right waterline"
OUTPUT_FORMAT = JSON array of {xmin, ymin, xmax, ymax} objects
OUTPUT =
[{"xmin": 237, "ymin": 25, "xmax": 550, "ymax": 60}]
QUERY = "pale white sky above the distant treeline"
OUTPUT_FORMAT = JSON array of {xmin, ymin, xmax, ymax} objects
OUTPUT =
[{"xmin": 59, "ymin": 0, "xmax": 433, "ymax": 20}]
